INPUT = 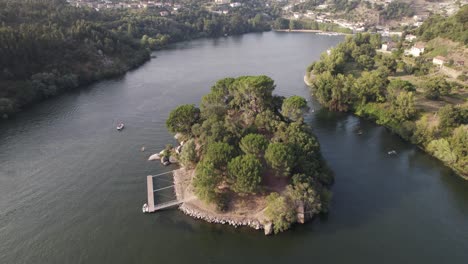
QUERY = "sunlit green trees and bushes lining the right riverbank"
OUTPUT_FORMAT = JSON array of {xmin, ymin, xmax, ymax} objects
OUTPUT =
[{"xmin": 304, "ymin": 7, "xmax": 468, "ymax": 180}]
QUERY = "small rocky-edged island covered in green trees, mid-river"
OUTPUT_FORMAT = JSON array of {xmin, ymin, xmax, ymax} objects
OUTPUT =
[{"xmin": 166, "ymin": 76, "xmax": 333, "ymax": 234}]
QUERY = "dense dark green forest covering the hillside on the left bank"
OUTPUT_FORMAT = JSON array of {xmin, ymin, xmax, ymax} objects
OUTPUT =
[{"xmin": 0, "ymin": 0, "xmax": 271, "ymax": 118}]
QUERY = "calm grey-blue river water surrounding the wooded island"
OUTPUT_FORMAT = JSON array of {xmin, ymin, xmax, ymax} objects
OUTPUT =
[{"xmin": 0, "ymin": 32, "xmax": 468, "ymax": 264}]
